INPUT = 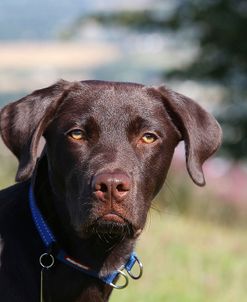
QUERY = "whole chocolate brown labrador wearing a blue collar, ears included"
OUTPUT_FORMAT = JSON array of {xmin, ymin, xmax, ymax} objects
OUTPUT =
[{"xmin": 0, "ymin": 80, "xmax": 221, "ymax": 302}]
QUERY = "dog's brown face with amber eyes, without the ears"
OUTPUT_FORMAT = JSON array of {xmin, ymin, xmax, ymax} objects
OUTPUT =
[{"xmin": 45, "ymin": 83, "xmax": 180, "ymax": 238}]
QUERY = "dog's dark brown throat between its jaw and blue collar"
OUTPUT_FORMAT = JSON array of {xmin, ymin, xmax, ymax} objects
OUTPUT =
[{"xmin": 34, "ymin": 158, "xmax": 135, "ymax": 275}]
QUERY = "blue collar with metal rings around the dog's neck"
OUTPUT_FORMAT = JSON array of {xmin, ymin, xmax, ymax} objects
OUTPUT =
[{"xmin": 29, "ymin": 185, "xmax": 143, "ymax": 289}]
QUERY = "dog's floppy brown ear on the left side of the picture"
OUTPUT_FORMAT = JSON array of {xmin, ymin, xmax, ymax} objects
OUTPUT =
[{"xmin": 0, "ymin": 80, "xmax": 70, "ymax": 181}]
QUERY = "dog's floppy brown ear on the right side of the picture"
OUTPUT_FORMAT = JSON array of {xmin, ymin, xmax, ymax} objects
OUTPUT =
[{"xmin": 156, "ymin": 86, "xmax": 222, "ymax": 186}]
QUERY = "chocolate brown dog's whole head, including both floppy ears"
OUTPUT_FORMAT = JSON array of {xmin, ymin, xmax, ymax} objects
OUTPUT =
[{"xmin": 0, "ymin": 81, "xmax": 221, "ymax": 241}]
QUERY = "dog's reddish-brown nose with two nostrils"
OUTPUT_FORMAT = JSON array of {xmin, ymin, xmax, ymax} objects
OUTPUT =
[{"xmin": 92, "ymin": 173, "xmax": 131, "ymax": 201}]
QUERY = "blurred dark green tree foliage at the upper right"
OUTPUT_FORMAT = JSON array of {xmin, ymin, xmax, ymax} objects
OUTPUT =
[{"xmin": 75, "ymin": 0, "xmax": 247, "ymax": 159}]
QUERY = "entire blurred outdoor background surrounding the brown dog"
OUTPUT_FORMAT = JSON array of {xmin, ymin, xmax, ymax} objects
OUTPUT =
[{"xmin": 0, "ymin": 0, "xmax": 247, "ymax": 302}]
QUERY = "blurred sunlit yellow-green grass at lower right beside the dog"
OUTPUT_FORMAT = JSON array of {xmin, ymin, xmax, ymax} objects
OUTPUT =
[{"xmin": 111, "ymin": 212, "xmax": 247, "ymax": 302}]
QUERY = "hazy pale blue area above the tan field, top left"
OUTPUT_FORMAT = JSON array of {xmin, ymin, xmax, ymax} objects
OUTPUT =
[{"xmin": 0, "ymin": 0, "xmax": 151, "ymax": 41}]
